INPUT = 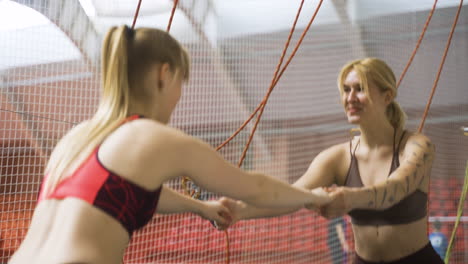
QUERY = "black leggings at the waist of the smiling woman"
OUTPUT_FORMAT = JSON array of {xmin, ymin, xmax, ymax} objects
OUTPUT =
[{"xmin": 353, "ymin": 243, "xmax": 444, "ymax": 264}]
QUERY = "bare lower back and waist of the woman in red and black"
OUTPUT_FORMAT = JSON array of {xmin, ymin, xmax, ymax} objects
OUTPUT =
[{"xmin": 8, "ymin": 198, "xmax": 129, "ymax": 264}]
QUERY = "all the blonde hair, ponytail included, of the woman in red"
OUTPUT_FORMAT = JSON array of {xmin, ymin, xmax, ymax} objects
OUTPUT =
[{"xmin": 43, "ymin": 26, "xmax": 189, "ymax": 194}]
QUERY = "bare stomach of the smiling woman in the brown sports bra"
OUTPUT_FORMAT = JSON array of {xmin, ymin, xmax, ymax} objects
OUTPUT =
[{"xmin": 353, "ymin": 218, "xmax": 429, "ymax": 262}]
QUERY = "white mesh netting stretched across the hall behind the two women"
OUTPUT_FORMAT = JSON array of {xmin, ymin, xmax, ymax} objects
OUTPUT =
[{"xmin": 0, "ymin": 0, "xmax": 468, "ymax": 263}]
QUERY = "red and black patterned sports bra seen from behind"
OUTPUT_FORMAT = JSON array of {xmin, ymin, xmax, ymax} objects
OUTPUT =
[{"xmin": 38, "ymin": 115, "xmax": 162, "ymax": 236}]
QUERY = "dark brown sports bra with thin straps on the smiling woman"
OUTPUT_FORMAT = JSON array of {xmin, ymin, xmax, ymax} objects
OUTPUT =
[{"xmin": 345, "ymin": 131, "xmax": 427, "ymax": 225}]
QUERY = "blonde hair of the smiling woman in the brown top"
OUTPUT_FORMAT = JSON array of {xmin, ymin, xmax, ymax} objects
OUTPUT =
[{"xmin": 338, "ymin": 58, "xmax": 406, "ymax": 128}]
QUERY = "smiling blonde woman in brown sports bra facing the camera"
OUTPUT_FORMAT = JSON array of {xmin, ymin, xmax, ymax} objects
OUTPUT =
[{"xmin": 222, "ymin": 58, "xmax": 443, "ymax": 264}]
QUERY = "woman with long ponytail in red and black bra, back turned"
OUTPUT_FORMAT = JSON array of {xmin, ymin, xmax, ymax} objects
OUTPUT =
[{"xmin": 9, "ymin": 26, "xmax": 330, "ymax": 264}]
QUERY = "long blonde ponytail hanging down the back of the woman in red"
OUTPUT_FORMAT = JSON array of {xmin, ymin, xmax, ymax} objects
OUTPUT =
[{"xmin": 42, "ymin": 26, "xmax": 133, "ymax": 195}]
